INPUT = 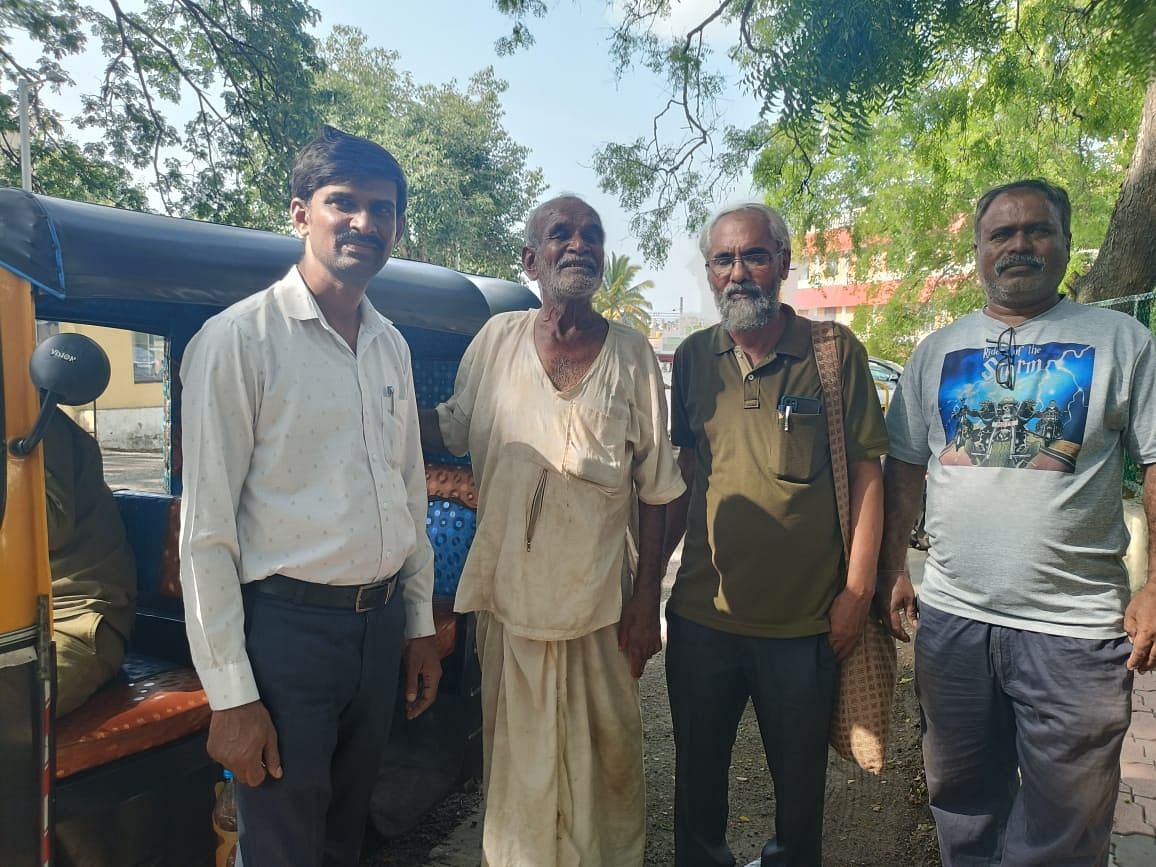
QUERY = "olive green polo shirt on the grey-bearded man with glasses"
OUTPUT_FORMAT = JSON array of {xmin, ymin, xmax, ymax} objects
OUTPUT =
[{"xmin": 667, "ymin": 305, "xmax": 888, "ymax": 638}]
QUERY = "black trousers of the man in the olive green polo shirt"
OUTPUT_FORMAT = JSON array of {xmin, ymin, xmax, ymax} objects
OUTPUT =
[{"xmin": 666, "ymin": 614, "xmax": 838, "ymax": 867}]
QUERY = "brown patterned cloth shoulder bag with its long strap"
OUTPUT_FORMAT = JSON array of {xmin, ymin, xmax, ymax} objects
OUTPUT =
[{"xmin": 810, "ymin": 321, "xmax": 896, "ymax": 773}]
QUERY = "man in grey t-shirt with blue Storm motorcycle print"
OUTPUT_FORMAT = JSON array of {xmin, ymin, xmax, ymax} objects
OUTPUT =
[{"xmin": 877, "ymin": 180, "xmax": 1156, "ymax": 865}]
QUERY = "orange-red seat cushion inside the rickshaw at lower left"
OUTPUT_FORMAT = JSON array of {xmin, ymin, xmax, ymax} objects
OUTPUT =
[{"xmin": 57, "ymin": 668, "xmax": 212, "ymax": 779}]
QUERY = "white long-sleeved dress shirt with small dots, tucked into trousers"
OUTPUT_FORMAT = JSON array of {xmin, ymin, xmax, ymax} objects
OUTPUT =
[{"xmin": 180, "ymin": 267, "xmax": 434, "ymax": 710}]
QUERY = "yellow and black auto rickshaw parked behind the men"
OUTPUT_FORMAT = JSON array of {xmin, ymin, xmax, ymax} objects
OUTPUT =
[{"xmin": 0, "ymin": 188, "xmax": 538, "ymax": 867}]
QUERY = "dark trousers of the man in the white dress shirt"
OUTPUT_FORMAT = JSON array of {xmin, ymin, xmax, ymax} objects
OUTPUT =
[{"xmin": 237, "ymin": 591, "xmax": 406, "ymax": 867}]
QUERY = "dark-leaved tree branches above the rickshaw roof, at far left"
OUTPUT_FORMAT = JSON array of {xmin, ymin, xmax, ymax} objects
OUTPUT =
[{"xmin": 0, "ymin": 0, "xmax": 317, "ymax": 225}]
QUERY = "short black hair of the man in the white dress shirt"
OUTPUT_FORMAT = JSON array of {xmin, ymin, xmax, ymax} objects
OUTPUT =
[{"xmin": 290, "ymin": 126, "xmax": 408, "ymax": 216}]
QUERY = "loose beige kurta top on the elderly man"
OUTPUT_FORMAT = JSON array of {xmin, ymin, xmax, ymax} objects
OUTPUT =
[{"xmin": 438, "ymin": 310, "xmax": 686, "ymax": 640}]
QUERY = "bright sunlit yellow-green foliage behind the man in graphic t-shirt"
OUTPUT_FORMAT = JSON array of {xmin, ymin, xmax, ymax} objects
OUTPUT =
[{"xmin": 754, "ymin": 2, "xmax": 1144, "ymax": 339}]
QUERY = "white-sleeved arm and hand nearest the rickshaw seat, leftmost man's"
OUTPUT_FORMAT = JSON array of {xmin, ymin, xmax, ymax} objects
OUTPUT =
[{"xmin": 180, "ymin": 320, "xmax": 281, "ymax": 786}]
